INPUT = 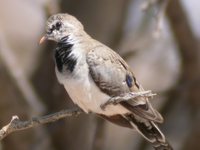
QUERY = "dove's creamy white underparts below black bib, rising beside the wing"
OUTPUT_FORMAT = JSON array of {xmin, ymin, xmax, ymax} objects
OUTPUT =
[{"xmin": 56, "ymin": 54, "xmax": 128, "ymax": 115}]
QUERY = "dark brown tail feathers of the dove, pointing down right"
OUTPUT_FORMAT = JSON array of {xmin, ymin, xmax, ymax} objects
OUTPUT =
[{"xmin": 124, "ymin": 114, "xmax": 173, "ymax": 150}]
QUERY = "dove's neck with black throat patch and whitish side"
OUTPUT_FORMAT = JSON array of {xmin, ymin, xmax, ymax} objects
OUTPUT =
[{"xmin": 54, "ymin": 31, "xmax": 92, "ymax": 72}]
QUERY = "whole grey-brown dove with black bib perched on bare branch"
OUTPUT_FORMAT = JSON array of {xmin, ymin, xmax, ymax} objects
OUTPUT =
[{"xmin": 40, "ymin": 14, "xmax": 172, "ymax": 150}]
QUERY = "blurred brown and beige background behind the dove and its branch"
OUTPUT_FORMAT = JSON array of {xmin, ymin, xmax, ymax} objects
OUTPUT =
[{"xmin": 0, "ymin": 0, "xmax": 200, "ymax": 150}]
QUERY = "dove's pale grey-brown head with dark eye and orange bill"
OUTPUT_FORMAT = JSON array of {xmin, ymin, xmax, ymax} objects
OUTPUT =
[{"xmin": 40, "ymin": 14, "xmax": 84, "ymax": 44}]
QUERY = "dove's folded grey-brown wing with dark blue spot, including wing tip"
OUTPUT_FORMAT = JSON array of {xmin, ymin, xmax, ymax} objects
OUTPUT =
[{"xmin": 86, "ymin": 44, "xmax": 163, "ymax": 123}]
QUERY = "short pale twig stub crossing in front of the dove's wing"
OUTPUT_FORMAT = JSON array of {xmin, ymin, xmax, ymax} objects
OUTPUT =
[{"xmin": 101, "ymin": 90, "xmax": 156, "ymax": 110}]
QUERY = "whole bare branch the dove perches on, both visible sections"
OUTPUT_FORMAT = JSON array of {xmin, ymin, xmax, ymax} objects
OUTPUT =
[{"xmin": 0, "ymin": 91, "xmax": 155, "ymax": 140}]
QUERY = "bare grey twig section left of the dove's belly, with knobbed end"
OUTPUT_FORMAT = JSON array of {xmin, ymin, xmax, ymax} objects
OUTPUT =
[{"xmin": 0, "ymin": 108, "xmax": 83, "ymax": 140}]
